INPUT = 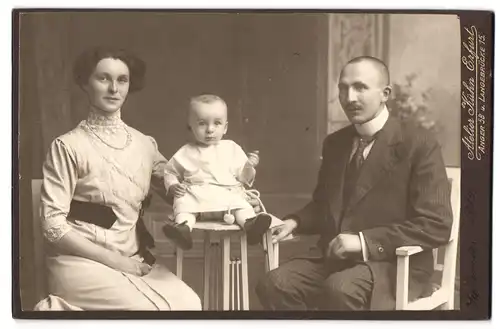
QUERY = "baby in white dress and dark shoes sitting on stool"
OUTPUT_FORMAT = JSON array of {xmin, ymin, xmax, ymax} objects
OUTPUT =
[{"xmin": 163, "ymin": 95, "xmax": 271, "ymax": 250}]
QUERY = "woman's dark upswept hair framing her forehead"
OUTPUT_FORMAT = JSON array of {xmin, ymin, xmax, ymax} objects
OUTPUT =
[{"xmin": 73, "ymin": 47, "xmax": 146, "ymax": 93}]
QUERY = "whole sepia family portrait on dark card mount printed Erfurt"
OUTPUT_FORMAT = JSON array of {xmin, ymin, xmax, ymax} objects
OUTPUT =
[{"xmin": 13, "ymin": 10, "xmax": 493, "ymax": 319}]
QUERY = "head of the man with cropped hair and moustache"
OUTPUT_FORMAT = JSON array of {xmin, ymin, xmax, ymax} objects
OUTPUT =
[{"xmin": 338, "ymin": 61, "xmax": 391, "ymax": 124}]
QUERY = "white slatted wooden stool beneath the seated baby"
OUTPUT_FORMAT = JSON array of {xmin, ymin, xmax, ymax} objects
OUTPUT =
[{"xmin": 176, "ymin": 217, "xmax": 281, "ymax": 311}]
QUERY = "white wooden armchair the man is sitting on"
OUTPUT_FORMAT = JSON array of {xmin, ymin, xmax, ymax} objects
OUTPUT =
[{"xmin": 396, "ymin": 168, "xmax": 460, "ymax": 311}]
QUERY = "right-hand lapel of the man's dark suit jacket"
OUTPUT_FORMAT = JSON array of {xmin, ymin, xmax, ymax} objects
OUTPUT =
[{"xmin": 346, "ymin": 118, "xmax": 402, "ymax": 212}]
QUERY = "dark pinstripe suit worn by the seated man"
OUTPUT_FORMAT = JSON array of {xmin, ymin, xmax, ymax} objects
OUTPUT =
[{"xmin": 257, "ymin": 117, "xmax": 452, "ymax": 310}]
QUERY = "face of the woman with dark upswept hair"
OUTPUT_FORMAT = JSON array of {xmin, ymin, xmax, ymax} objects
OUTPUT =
[{"xmin": 84, "ymin": 58, "xmax": 130, "ymax": 114}]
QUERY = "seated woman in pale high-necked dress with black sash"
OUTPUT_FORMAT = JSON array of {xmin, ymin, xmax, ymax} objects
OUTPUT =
[{"xmin": 35, "ymin": 48, "xmax": 201, "ymax": 310}]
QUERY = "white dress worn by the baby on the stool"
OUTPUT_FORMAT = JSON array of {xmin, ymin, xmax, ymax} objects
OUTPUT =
[{"xmin": 164, "ymin": 140, "xmax": 255, "ymax": 216}]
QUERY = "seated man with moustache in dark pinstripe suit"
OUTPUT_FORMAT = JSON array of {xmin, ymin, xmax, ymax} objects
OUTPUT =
[{"xmin": 257, "ymin": 56, "xmax": 453, "ymax": 310}]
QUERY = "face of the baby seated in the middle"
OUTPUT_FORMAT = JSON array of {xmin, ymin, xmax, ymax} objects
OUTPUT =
[{"xmin": 189, "ymin": 102, "xmax": 227, "ymax": 145}]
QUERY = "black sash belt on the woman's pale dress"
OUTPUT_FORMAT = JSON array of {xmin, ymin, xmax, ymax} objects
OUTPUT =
[{"xmin": 68, "ymin": 194, "xmax": 155, "ymax": 265}]
